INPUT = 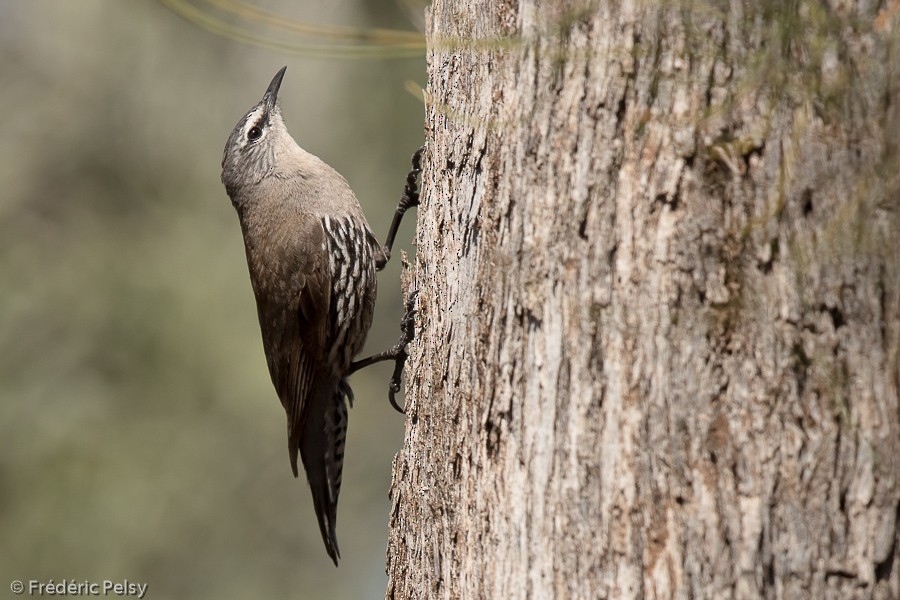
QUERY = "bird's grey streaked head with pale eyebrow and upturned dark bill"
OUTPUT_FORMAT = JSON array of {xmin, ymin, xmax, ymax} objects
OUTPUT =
[{"xmin": 222, "ymin": 67, "xmax": 295, "ymax": 201}]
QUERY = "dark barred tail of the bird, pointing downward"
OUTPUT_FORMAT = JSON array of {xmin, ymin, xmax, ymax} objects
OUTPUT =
[{"xmin": 298, "ymin": 377, "xmax": 353, "ymax": 566}]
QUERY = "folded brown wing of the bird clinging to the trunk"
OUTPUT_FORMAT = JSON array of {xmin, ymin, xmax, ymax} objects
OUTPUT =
[{"xmin": 257, "ymin": 214, "xmax": 331, "ymax": 477}]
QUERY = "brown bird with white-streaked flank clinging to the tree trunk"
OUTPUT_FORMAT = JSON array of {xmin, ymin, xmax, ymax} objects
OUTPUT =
[{"xmin": 222, "ymin": 67, "xmax": 389, "ymax": 566}]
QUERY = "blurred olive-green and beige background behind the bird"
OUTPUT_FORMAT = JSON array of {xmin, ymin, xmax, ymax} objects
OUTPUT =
[{"xmin": 0, "ymin": 0, "xmax": 425, "ymax": 599}]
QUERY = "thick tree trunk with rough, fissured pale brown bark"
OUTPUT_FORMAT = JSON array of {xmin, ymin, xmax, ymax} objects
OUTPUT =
[{"xmin": 387, "ymin": 0, "xmax": 900, "ymax": 599}]
